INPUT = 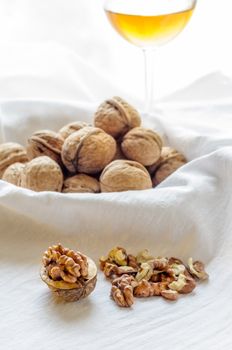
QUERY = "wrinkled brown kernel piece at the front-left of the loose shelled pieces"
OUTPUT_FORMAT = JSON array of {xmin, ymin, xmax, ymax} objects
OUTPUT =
[{"xmin": 111, "ymin": 275, "xmax": 137, "ymax": 307}]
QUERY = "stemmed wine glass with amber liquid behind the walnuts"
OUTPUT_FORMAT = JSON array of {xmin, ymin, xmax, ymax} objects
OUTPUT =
[{"xmin": 104, "ymin": 0, "xmax": 197, "ymax": 115}]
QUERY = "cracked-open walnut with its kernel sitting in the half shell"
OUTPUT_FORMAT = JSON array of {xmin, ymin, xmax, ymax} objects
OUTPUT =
[{"xmin": 40, "ymin": 244, "xmax": 97, "ymax": 301}]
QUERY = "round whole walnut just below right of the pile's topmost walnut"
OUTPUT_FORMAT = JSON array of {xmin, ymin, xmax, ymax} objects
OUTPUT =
[{"xmin": 121, "ymin": 127, "xmax": 162, "ymax": 166}]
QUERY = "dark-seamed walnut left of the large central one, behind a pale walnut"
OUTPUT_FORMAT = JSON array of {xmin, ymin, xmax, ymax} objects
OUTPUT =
[{"xmin": 27, "ymin": 130, "xmax": 64, "ymax": 165}]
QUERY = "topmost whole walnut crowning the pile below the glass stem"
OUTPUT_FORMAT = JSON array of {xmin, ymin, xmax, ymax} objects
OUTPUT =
[{"xmin": 94, "ymin": 97, "xmax": 141, "ymax": 139}]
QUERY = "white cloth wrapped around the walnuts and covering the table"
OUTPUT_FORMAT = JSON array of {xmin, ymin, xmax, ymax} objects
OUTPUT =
[{"xmin": 0, "ymin": 69, "xmax": 232, "ymax": 350}]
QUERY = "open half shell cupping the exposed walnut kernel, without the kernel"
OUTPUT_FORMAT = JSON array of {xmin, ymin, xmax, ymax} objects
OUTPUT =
[{"xmin": 40, "ymin": 257, "xmax": 97, "ymax": 302}]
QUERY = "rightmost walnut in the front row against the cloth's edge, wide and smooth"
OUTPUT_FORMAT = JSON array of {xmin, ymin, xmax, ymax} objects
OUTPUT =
[{"xmin": 100, "ymin": 160, "xmax": 152, "ymax": 192}]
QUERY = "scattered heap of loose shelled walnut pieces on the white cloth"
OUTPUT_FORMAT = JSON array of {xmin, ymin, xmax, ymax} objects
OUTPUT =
[{"xmin": 99, "ymin": 247, "xmax": 208, "ymax": 307}]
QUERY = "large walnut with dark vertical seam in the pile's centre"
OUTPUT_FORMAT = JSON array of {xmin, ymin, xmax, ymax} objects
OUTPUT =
[{"xmin": 61, "ymin": 127, "xmax": 116, "ymax": 174}]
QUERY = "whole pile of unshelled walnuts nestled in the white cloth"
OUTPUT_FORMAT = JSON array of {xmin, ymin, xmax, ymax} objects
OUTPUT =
[{"xmin": 0, "ymin": 97, "xmax": 186, "ymax": 193}]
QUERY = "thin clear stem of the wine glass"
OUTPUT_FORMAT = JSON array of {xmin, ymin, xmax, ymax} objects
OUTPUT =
[{"xmin": 143, "ymin": 49, "xmax": 154, "ymax": 116}]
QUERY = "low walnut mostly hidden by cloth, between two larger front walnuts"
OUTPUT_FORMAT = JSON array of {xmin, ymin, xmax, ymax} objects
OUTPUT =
[{"xmin": 62, "ymin": 174, "xmax": 100, "ymax": 193}]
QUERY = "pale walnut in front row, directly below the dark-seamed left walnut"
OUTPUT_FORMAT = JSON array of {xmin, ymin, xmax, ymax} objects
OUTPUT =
[{"xmin": 21, "ymin": 156, "xmax": 63, "ymax": 192}]
